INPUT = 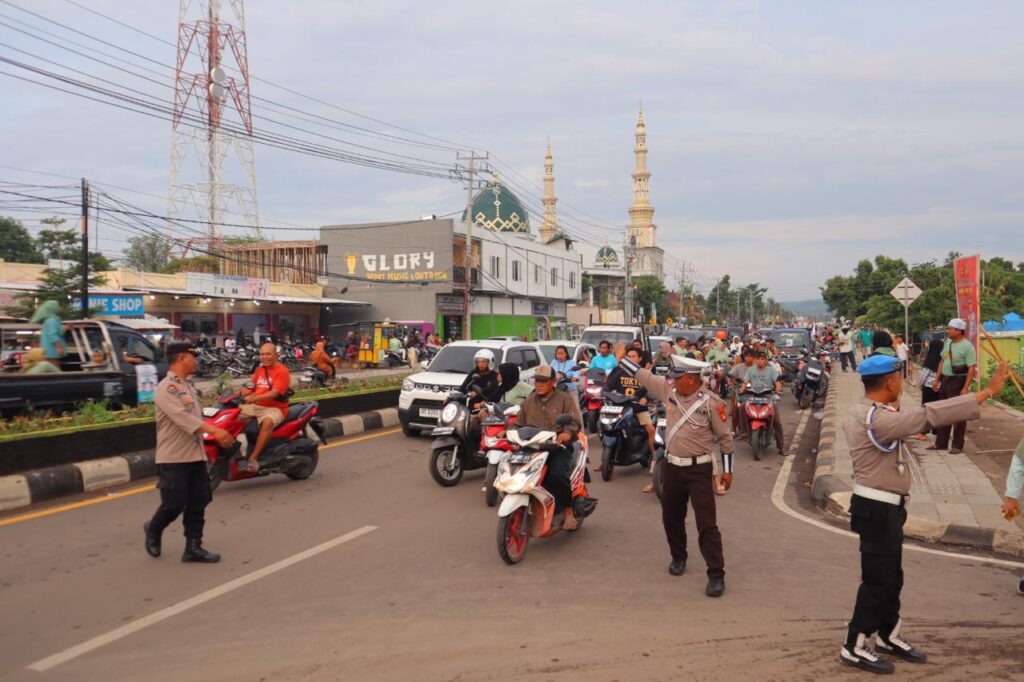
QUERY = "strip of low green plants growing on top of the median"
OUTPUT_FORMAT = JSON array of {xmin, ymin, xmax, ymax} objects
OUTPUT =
[{"xmin": 0, "ymin": 377, "xmax": 404, "ymax": 443}]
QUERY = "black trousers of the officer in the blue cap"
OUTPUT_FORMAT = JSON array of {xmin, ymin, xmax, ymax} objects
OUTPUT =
[{"xmin": 847, "ymin": 495, "xmax": 906, "ymax": 647}]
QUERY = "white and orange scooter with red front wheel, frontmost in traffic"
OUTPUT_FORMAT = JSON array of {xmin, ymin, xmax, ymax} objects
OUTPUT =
[{"xmin": 495, "ymin": 415, "xmax": 597, "ymax": 564}]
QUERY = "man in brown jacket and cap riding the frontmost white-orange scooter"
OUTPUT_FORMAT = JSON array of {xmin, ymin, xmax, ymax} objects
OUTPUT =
[{"xmin": 517, "ymin": 360, "xmax": 585, "ymax": 530}]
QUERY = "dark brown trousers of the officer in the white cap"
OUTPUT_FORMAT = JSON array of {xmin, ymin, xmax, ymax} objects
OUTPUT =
[{"xmin": 662, "ymin": 461, "xmax": 725, "ymax": 578}]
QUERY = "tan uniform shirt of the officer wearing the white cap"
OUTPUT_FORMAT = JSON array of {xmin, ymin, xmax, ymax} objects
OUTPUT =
[{"xmin": 622, "ymin": 358, "xmax": 733, "ymax": 474}]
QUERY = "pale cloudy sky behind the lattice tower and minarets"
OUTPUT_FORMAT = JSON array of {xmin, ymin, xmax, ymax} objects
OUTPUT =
[{"xmin": 0, "ymin": 0, "xmax": 1024, "ymax": 301}]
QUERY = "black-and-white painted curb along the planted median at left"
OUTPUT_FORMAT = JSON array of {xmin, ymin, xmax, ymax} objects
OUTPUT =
[{"xmin": 0, "ymin": 408, "xmax": 399, "ymax": 511}]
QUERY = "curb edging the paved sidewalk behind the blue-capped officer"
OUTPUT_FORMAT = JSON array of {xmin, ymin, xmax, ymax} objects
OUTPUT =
[{"xmin": 811, "ymin": 378, "xmax": 1024, "ymax": 556}]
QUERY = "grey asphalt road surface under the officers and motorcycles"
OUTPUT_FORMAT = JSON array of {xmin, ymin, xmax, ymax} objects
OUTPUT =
[{"xmin": 0, "ymin": 391, "xmax": 1024, "ymax": 682}]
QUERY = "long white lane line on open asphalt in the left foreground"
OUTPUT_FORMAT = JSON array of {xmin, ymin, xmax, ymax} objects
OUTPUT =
[{"xmin": 29, "ymin": 525, "xmax": 377, "ymax": 673}]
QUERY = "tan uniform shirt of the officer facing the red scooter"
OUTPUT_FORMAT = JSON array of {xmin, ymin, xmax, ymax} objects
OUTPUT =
[{"xmin": 155, "ymin": 372, "xmax": 206, "ymax": 464}]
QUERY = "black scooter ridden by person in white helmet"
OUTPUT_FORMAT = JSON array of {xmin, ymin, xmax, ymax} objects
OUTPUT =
[{"xmin": 429, "ymin": 391, "xmax": 487, "ymax": 487}]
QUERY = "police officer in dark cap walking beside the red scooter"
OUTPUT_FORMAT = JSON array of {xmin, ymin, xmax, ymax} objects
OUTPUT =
[{"xmin": 143, "ymin": 343, "xmax": 234, "ymax": 563}]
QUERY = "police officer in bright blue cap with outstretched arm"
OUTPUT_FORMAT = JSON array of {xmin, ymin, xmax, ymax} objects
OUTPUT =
[{"xmin": 840, "ymin": 355, "xmax": 1010, "ymax": 674}]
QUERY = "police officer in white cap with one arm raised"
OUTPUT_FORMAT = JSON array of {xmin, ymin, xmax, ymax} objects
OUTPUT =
[{"xmin": 615, "ymin": 344, "xmax": 733, "ymax": 597}]
